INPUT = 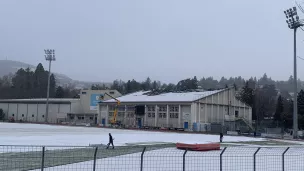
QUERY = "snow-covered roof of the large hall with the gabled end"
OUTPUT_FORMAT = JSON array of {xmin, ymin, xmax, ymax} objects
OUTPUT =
[{"xmin": 104, "ymin": 90, "xmax": 223, "ymax": 103}]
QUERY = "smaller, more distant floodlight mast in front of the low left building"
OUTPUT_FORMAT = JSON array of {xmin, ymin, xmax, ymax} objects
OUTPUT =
[{"xmin": 44, "ymin": 49, "xmax": 56, "ymax": 123}]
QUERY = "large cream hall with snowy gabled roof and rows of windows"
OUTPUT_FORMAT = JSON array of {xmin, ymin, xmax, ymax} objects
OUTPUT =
[{"xmin": 98, "ymin": 88, "xmax": 252, "ymax": 130}]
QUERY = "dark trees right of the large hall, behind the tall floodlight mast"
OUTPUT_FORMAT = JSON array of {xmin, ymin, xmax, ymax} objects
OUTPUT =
[{"xmin": 237, "ymin": 80, "xmax": 304, "ymax": 129}]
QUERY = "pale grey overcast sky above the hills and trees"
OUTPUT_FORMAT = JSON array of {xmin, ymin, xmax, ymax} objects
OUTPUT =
[{"xmin": 0, "ymin": 0, "xmax": 304, "ymax": 82}]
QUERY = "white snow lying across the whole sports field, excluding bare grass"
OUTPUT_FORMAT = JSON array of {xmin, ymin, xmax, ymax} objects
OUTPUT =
[{"xmin": 5, "ymin": 123, "xmax": 304, "ymax": 171}]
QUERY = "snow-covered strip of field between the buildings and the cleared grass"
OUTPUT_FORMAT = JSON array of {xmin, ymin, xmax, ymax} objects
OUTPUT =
[{"xmin": 0, "ymin": 123, "xmax": 263, "ymax": 146}]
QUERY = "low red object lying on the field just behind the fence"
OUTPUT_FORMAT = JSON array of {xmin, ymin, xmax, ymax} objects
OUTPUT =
[{"xmin": 176, "ymin": 143, "xmax": 221, "ymax": 151}]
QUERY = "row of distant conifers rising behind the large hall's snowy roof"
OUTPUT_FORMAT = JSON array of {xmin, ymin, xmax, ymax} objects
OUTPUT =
[{"xmin": 91, "ymin": 74, "xmax": 304, "ymax": 95}]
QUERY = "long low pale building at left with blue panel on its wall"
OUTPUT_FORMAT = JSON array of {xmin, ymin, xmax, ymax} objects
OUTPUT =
[{"xmin": 0, "ymin": 90, "xmax": 121, "ymax": 124}]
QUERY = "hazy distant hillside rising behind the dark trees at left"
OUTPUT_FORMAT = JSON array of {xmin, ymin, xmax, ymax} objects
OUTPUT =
[{"xmin": 0, "ymin": 60, "xmax": 110, "ymax": 89}]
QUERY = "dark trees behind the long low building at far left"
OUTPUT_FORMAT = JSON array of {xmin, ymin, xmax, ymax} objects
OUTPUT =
[{"xmin": 0, "ymin": 63, "xmax": 78, "ymax": 99}]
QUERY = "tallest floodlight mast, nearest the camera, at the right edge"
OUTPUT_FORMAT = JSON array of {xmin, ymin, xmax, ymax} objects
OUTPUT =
[{"xmin": 284, "ymin": 7, "xmax": 303, "ymax": 139}]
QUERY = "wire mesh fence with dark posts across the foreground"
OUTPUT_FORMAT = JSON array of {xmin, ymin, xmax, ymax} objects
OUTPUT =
[{"xmin": 0, "ymin": 145, "xmax": 304, "ymax": 171}]
